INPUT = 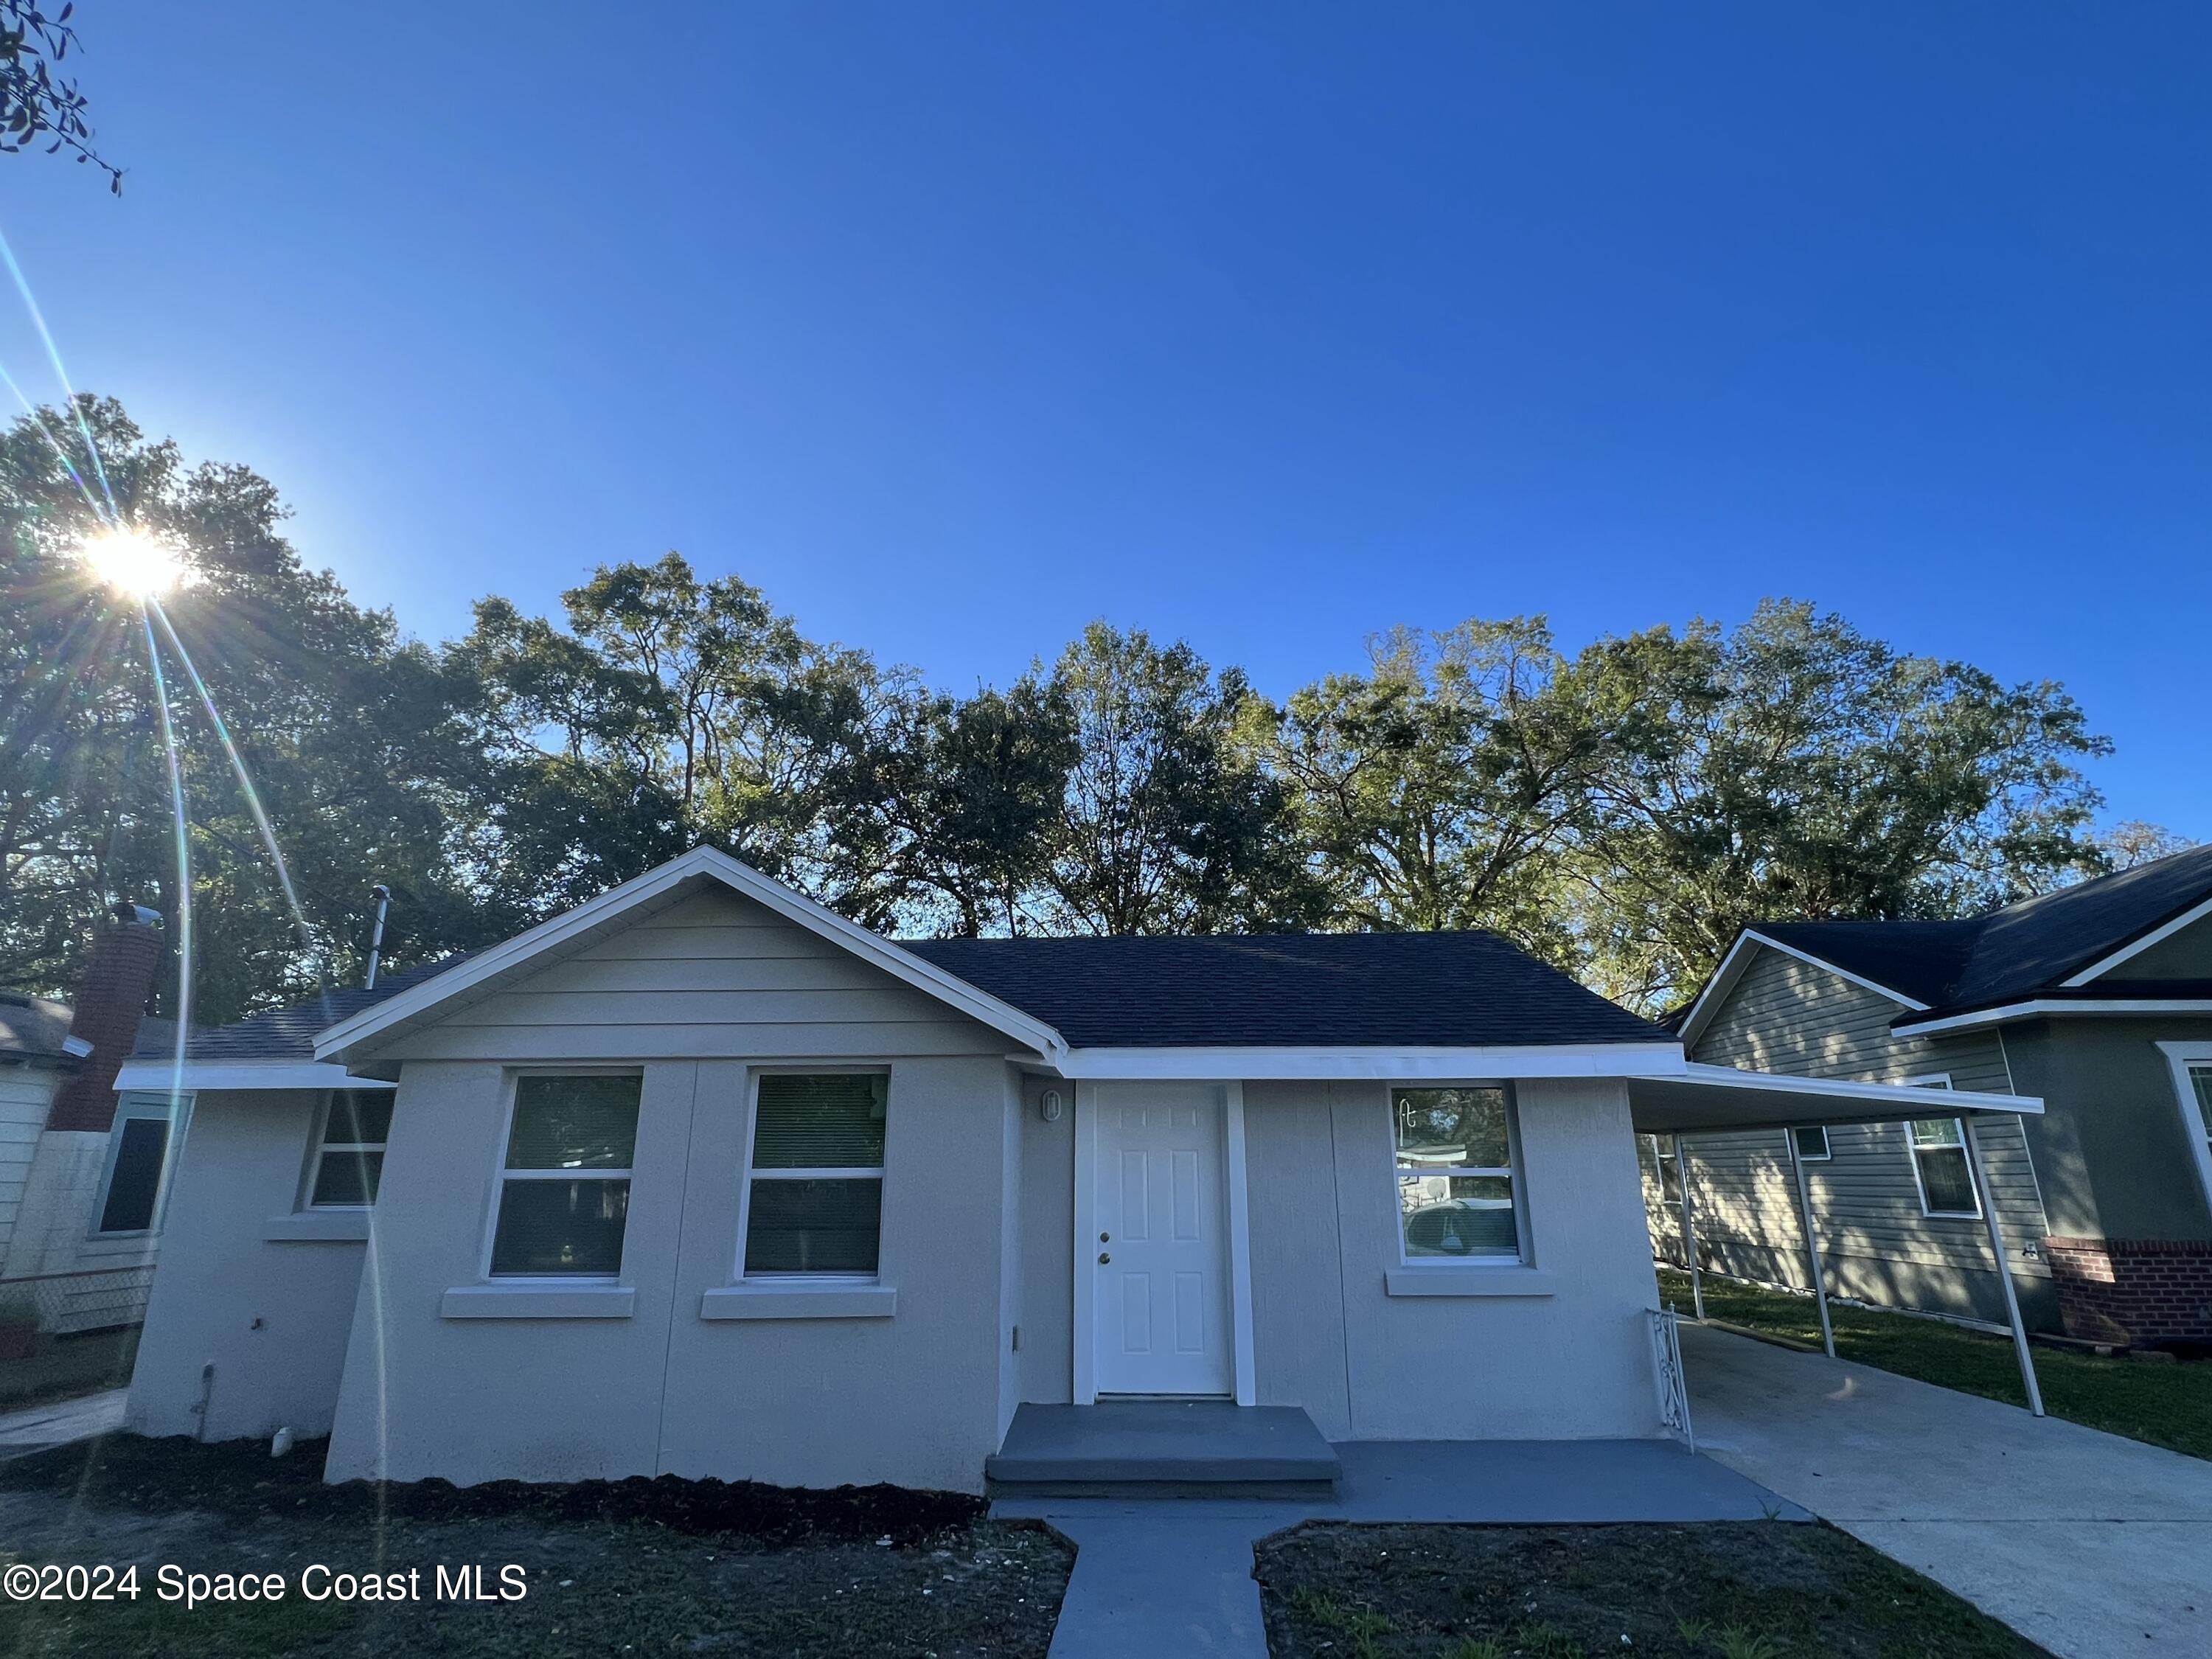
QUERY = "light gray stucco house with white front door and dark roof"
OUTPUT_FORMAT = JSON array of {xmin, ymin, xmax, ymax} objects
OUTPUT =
[{"xmin": 117, "ymin": 849, "xmax": 2035, "ymax": 1491}]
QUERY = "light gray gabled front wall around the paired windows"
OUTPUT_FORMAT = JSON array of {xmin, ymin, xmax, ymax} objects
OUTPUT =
[{"xmin": 330, "ymin": 894, "xmax": 1015, "ymax": 1491}]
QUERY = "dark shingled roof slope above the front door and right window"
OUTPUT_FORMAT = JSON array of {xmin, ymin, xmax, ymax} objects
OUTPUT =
[{"xmin": 900, "ymin": 933, "xmax": 1668, "ymax": 1048}]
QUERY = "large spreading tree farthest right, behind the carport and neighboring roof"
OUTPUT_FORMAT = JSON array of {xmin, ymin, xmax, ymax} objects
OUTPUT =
[{"xmin": 1566, "ymin": 599, "xmax": 2110, "ymax": 1006}]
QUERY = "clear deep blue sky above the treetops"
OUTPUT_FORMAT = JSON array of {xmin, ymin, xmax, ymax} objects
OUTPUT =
[{"xmin": 0, "ymin": 0, "xmax": 2212, "ymax": 838}]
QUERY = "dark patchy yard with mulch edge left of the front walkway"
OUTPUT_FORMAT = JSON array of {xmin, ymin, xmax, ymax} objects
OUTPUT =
[{"xmin": 0, "ymin": 1436, "xmax": 1071, "ymax": 1659}]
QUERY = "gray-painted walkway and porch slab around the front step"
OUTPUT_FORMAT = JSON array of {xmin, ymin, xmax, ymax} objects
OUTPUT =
[{"xmin": 991, "ymin": 1440, "xmax": 1807, "ymax": 1659}]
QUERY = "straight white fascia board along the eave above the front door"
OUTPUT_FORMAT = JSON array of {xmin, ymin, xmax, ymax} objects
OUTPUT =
[{"xmin": 1057, "ymin": 1042, "xmax": 1688, "ymax": 1082}]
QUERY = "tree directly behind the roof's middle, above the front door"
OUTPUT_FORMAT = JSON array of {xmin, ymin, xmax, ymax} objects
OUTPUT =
[{"xmin": 1040, "ymin": 622, "xmax": 1323, "ymax": 933}]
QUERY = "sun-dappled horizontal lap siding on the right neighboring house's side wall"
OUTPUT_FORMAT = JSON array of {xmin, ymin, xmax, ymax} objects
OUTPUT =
[{"xmin": 1672, "ymin": 949, "xmax": 2057, "ymax": 1327}]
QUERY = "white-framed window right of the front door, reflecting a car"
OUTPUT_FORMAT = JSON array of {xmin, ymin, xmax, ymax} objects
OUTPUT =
[{"xmin": 1391, "ymin": 1088, "xmax": 1522, "ymax": 1261}]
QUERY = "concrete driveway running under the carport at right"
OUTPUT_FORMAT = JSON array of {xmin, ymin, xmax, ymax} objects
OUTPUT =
[{"xmin": 1681, "ymin": 1323, "xmax": 2212, "ymax": 1659}]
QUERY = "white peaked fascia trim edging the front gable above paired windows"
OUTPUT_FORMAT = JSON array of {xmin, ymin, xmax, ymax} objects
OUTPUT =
[{"xmin": 314, "ymin": 847, "xmax": 1066, "ymax": 1060}]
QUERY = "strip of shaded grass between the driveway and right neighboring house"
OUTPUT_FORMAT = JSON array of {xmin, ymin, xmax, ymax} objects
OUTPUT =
[{"xmin": 1659, "ymin": 1267, "xmax": 2212, "ymax": 1458}]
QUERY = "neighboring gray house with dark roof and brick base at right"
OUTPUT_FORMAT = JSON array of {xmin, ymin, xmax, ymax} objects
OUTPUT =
[{"xmin": 1641, "ymin": 847, "xmax": 2212, "ymax": 1345}]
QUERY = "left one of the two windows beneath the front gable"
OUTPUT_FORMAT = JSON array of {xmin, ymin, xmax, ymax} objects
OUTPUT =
[{"xmin": 487, "ymin": 1073, "xmax": 644, "ymax": 1279}]
